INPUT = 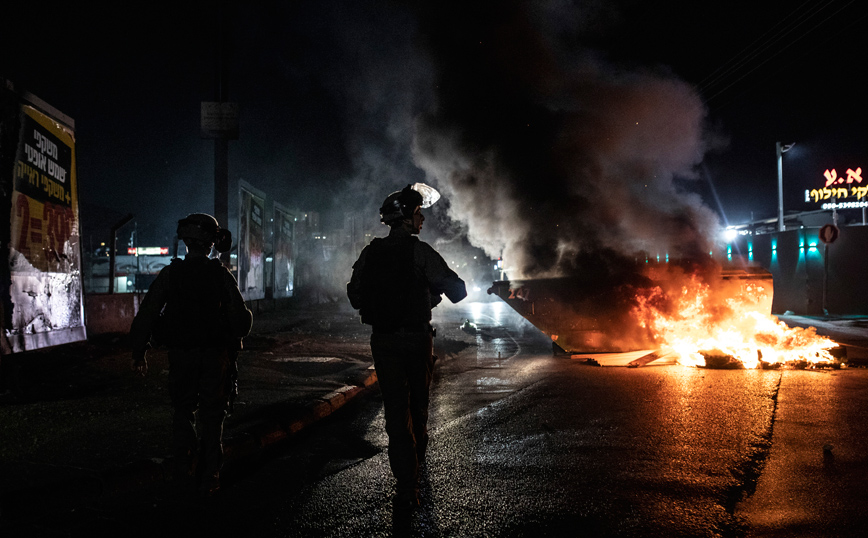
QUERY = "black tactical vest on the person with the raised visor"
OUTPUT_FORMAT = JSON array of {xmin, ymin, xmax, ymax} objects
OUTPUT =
[{"xmin": 360, "ymin": 236, "xmax": 431, "ymax": 328}]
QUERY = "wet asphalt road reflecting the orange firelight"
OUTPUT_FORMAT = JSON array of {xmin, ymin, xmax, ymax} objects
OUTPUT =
[{"xmin": 57, "ymin": 303, "xmax": 868, "ymax": 537}]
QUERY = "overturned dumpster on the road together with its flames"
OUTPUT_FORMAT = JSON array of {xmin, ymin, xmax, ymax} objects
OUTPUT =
[{"xmin": 489, "ymin": 256, "xmax": 842, "ymax": 369}]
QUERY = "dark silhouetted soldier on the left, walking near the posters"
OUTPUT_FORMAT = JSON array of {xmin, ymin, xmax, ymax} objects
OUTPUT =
[{"xmin": 130, "ymin": 213, "xmax": 253, "ymax": 494}]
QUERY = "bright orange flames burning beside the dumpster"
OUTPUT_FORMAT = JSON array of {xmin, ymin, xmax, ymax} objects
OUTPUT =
[{"xmin": 634, "ymin": 276, "xmax": 837, "ymax": 368}]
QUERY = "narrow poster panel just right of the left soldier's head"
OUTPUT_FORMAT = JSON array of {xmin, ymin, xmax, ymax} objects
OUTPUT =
[{"xmin": 237, "ymin": 181, "xmax": 265, "ymax": 301}]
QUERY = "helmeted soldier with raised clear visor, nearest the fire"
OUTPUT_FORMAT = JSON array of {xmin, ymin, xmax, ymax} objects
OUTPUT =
[{"xmin": 347, "ymin": 183, "xmax": 467, "ymax": 508}]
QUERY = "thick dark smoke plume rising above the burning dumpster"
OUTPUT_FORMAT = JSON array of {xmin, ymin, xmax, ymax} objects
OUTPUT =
[{"xmin": 414, "ymin": 1, "xmax": 718, "ymax": 277}]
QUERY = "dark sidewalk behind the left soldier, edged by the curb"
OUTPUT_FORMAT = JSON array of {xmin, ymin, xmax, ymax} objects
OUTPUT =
[{"xmin": 0, "ymin": 305, "xmax": 376, "ymax": 516}]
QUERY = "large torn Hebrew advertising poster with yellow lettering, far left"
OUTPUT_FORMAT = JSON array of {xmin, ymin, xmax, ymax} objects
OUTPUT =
[{"xmin": 6, "ymin": 105, "xmax": 87, "ymax": 352}]
